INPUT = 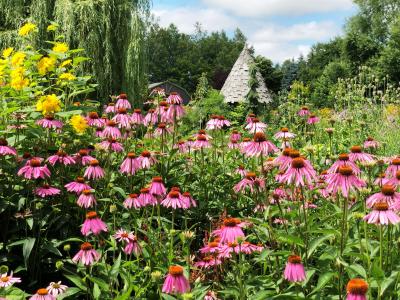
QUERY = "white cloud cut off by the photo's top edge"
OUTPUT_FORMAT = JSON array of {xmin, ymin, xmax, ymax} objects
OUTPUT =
[{"xmin": 202, "ymin": 0, "xmax": 354, "ymax": 17}]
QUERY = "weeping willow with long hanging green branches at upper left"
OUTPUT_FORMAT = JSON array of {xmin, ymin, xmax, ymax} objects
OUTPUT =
[{"xmin": 0, "ymin": 0, "xmax": 150, "ymax": 101}]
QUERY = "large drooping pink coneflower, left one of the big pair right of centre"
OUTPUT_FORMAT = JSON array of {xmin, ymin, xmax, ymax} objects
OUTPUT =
[{"xmin": 279, "ymin": 157, "xmax": 317, "ymax": 186}]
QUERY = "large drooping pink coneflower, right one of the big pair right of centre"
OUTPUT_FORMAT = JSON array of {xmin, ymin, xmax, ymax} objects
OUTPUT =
[{"xmin": 326, "ymin": 166, "xmax": 366, "ymax": 197}]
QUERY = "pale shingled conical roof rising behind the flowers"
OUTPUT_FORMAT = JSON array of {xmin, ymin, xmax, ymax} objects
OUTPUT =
[{"xmin": 221, "ymin": 45, "xmax": 272, "ymax": 103}]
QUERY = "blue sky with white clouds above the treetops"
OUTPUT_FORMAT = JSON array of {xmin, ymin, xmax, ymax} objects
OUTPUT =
[{"xmin": 152, "ymin": 0, "xmax": 356, "ymax": 63}]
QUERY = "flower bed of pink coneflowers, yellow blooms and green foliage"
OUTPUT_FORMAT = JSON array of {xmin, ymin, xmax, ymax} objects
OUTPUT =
[{"xmin": 0, "ymin": 23, "xmax": 400, "ymax": 300}]
